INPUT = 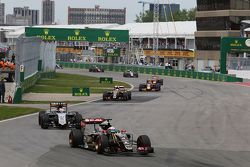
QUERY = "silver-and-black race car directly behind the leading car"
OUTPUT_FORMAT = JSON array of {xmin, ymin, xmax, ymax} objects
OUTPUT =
[{"xmin": 38, "ymin": 102, "xmax": 82, "ymax": 129}]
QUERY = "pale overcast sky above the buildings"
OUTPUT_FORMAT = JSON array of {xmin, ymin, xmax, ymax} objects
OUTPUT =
[{"xmin": 0, "ymin": 0, "xmax": 196, "ymax": 24}]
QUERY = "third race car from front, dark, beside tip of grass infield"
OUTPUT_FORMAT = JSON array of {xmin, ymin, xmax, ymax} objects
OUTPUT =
[{"xmin": 103, "ymin": 86, "xmax": 131, "ymax": 101}]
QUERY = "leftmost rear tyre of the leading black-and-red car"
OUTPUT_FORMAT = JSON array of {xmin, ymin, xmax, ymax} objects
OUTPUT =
[{"xmin": 69, "ymin": 129, "xmax": 84, "ymax": 148}]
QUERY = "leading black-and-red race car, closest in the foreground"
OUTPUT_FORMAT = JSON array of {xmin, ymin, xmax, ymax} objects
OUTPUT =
[{"xmin": 69, "ymin": 118, "xmax": 154, "ymax": 155}]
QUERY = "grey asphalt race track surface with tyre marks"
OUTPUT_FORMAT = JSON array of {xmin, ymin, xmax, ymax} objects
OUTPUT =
[{"xmin": 0, "ymin": 70, "xmax": 250, "ymax": 167}]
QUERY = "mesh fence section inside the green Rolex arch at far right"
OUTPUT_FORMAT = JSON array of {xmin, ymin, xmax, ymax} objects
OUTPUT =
[{"xmin": 227, "ymin": 57, "xmax": 250, "ymax": 70}]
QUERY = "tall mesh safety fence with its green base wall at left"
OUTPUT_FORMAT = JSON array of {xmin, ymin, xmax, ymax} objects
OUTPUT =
[{"xmin": 13, "ymin": 36, "xmax": 56, "ymax": 103}]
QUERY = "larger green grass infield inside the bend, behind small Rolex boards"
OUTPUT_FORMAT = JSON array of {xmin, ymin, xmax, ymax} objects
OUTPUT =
[{"xmin": 25, "ymin": 73, "xmax": 130, "ymax": 93}]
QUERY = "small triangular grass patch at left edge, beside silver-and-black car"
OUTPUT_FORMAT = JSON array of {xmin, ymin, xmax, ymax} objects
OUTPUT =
[{"xmin": 0, "ymin": 106, "xmax": 42, "ymax": 120}]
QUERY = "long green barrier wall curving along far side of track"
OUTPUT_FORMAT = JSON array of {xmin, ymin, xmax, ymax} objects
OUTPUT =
[{"xmin": 57, "ymin": 62, "xmax": 243, "ymax": 82}]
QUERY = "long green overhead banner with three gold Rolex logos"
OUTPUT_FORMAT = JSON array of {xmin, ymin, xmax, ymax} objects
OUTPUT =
[{"xmin": 25, "ymin": 27, "xmax": 129, "ymax": 42}]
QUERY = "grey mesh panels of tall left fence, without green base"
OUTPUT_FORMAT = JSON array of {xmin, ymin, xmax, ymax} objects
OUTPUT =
[{"xmin": 15, "ymin": 36, "xmax": 56, "ymax": 86}]
